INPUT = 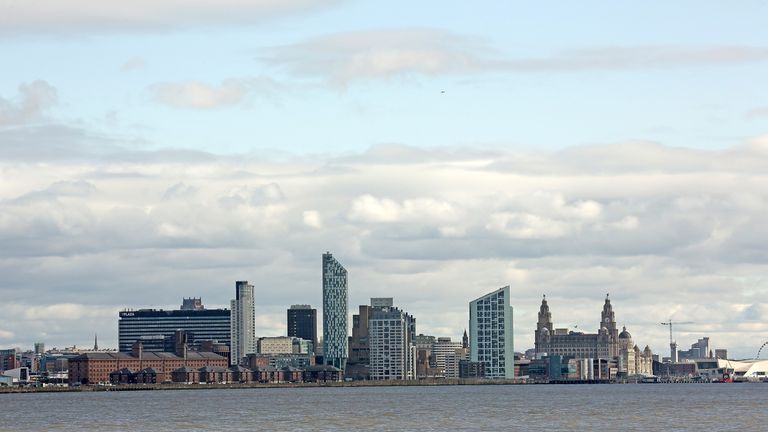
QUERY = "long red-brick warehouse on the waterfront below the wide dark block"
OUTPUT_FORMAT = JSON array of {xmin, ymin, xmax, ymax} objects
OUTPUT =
[{"xmin": 69, "ymin": 347, "xmax": 229, "ymax": 385}]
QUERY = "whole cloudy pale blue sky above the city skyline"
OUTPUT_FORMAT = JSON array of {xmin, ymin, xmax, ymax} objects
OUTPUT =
[{"xmin": 0, "ymin": 0, "xmax": 768, "ymax": 357}]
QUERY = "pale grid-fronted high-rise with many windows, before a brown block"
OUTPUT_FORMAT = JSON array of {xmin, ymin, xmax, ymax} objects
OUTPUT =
[{"xmin": 368, "ymin": 307, "xmax": 416, "ymax": 380}]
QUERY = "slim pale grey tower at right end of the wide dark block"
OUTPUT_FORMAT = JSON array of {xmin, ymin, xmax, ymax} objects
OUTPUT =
[{"xmin": 230, "ymin": 281, "xmax": 256, "ymax": 364}]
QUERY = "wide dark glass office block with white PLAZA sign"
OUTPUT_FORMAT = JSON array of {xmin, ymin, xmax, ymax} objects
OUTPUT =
[{"xmin": 117, "ymin": 309, "xmax": 231, "ymax": 353}]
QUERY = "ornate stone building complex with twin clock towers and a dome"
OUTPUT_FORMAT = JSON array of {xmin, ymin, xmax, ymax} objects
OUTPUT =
[{"xmin": 535, "ymin": 295, "xmax": 653, "ymax": 375}]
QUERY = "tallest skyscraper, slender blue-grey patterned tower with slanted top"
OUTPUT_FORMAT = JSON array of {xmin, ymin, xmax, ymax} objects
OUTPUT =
[{"xmin": 323, "ymin": 252, "xmax": 348, "ymax": 369}]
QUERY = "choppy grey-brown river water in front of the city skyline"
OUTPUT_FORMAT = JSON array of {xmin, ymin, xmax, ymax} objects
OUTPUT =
[{"xmin": 0, "ymin": 383, "xmax": 768, "ymax": 432}]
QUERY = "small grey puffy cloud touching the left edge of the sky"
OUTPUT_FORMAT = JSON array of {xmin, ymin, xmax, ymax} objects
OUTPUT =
[{"xmin": 0, "ymin": 80, "xmax": 57, "ymax": 126}]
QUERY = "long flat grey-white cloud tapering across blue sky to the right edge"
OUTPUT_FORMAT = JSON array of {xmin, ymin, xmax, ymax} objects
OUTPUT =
[{"xmin": 262, "ymin": 28, "xmax": 768, "ymax": 87}]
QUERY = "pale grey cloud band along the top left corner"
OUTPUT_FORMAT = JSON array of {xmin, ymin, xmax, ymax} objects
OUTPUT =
[{"xmin": 0, "ymin": 0, "xmax": 337, "ymax": 34}]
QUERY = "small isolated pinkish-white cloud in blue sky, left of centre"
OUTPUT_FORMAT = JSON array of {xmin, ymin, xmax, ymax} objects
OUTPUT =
[{"xmin": 149, "ymin": 77, "xmax": 280, "ymax": 109}]
